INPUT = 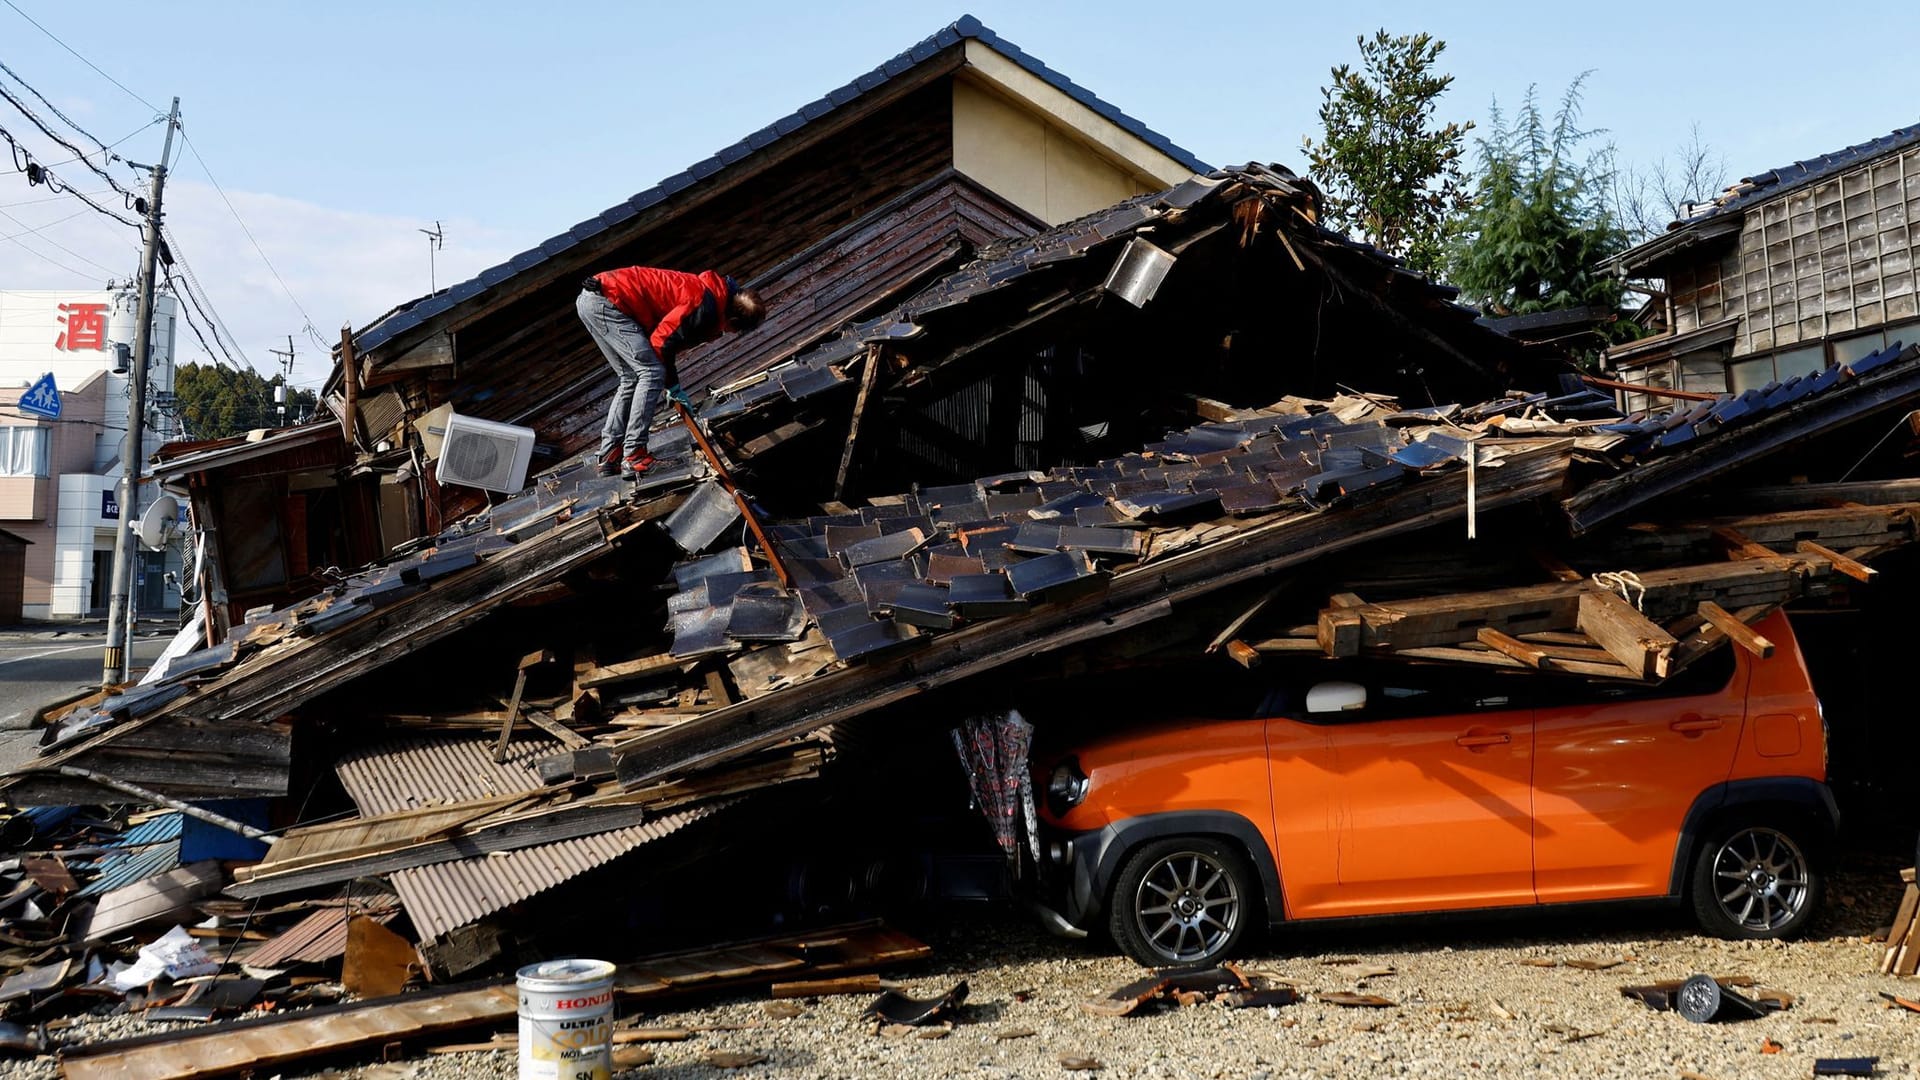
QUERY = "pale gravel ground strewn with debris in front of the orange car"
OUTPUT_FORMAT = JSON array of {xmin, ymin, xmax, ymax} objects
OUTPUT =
[{"xmin": 6, "ymin": 859, "xmax": 1920, "ymax": 1080}]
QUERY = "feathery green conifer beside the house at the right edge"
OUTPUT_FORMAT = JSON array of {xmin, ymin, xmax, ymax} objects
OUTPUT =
[{"xmin": 1450, "ymin": 75, "xmax": 1632, "ymax": 334}]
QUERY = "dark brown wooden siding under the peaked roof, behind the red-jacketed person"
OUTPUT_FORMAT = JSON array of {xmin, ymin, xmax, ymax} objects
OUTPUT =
[{"xmin": 426, "ymin": 81, "xmax": 952, "ymax": 465}]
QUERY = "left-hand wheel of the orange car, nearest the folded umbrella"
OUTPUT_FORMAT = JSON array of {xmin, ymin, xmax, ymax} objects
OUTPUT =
[{"xmin": 1108, "ymin": 836, "xmax": 1260, "ymax": 967}]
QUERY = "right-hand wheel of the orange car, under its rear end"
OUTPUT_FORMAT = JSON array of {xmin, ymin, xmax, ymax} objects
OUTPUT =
[{"xmin": 1692, "ymin": 824, "xmax": 1826, "ymax": 938}]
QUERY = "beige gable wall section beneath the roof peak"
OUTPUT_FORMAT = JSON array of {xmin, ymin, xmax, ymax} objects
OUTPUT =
[{"xmin": 954, "ymin": 42, "xmax": 1190, "ymax": 225}]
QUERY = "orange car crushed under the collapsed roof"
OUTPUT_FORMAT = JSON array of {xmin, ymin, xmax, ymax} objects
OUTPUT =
[{"xmin": 1037, "ymin": 615, "xmax": 1839, "ymax": 967}]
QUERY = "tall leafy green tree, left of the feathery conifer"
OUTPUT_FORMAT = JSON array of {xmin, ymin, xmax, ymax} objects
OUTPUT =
[{"xmin": 1306, "ymin": 31, "xmax": 1473, "ymax": 273}]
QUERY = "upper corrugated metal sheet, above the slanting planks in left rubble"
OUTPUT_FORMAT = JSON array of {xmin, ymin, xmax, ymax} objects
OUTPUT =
[{"xmin": 334, "ymin": 734, "xmax": 561, "ymax": 817}]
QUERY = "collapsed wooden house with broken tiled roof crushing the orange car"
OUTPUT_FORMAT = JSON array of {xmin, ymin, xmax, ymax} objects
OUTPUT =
[{"xmin": 11, "ymin": 145, "xmax": 1920, "ymax": 974}]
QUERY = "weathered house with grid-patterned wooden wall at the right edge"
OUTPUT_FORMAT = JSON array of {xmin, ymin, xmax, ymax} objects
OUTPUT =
[{"xmin": 1607, "ymin": 125, "xmax": 1920, "ymax": 411}]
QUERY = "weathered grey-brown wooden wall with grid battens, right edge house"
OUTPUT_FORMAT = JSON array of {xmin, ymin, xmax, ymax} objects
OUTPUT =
[{"xmin": 1668, "ymin": 150, "xmax": 1920, "ymax": 355}]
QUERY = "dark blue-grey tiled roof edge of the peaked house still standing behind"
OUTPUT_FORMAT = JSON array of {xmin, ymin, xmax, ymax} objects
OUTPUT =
[{"xmin": 355, "ymin": 15, "xmax": 1208, "ymax": 354}]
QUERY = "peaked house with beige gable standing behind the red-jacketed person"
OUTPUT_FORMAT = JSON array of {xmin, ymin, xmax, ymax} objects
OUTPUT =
[{"xmin": 180, "ymin": 17, "xmax": 1206, "ymax": 626}]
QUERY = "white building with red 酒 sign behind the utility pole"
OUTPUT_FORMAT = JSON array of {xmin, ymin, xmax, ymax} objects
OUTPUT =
[{"xmin": 0, "ymin": 288, "xmax": 180, "ymax": 619}]
